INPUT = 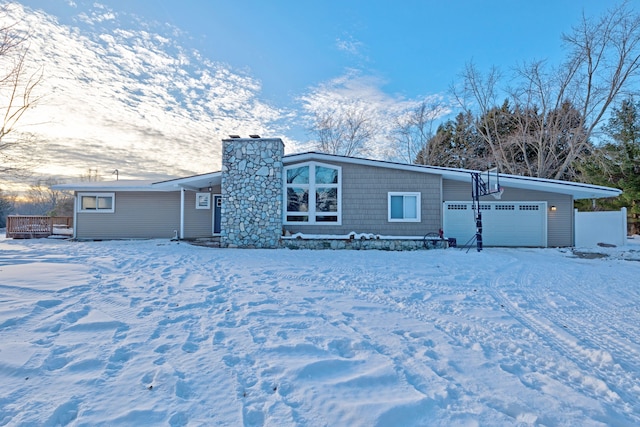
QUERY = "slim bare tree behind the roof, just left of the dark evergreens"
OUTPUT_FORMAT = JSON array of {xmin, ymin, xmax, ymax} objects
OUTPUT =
[{"xmin": 393, "ymin": 100, "xmax": 446, "ymax": 164}]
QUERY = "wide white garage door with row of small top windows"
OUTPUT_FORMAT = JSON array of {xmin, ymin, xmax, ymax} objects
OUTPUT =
[{"xmin": 443, "ymin": 202, "xmax": 547, "ymax": 247}]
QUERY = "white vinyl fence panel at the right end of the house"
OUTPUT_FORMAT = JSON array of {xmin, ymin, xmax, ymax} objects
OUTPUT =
[{"xmin": 575, "ymin": 208, "xmax": 627, "ymax": 247}]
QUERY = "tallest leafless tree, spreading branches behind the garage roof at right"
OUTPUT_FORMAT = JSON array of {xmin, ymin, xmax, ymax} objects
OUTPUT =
[{"xmin": 456, "ymin": 3, "xmax": 640, "ymax": 179}]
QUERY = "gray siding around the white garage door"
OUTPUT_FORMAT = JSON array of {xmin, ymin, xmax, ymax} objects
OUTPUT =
[{"xmin": 442, "ymin": 178, "xmax": 574, "ymax": 247}]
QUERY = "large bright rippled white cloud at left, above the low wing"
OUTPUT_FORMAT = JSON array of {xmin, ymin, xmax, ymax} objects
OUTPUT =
[{"xmin": 1, "ymin": 4, "xmax": 290, "ymax": 192}]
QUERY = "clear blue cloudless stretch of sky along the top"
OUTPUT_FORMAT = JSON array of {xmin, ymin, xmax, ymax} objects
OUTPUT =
[{"xmin": 22, "ymin": 0, "xmax": 616, "ymax": 103}]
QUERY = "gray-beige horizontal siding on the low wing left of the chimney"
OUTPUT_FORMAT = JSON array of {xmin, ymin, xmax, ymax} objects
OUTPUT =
[{"xmin": 76, "ymin": 191, "xmax": 179, "ymax": 239}]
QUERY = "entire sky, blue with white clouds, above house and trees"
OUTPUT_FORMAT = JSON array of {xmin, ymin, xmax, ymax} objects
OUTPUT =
[{"xmin": 3, "ymin": 0, "xmax": 616, "ymax": 188}]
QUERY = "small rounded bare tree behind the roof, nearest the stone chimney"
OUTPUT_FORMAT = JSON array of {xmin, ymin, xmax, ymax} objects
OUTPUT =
[{"xmin": 310, "ymin": 101, "xmax": 378, "ymax": 156}]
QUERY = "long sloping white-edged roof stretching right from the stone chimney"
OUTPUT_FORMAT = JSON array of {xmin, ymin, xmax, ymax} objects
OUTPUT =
[{"xmin": 282, "ymin": 151, "xmax": 622, "ymax": 200}]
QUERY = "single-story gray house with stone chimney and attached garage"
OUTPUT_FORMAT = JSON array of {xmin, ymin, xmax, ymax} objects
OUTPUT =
[{"xmin": 56, "ymin": 137, "xmax": 620, "ymax": 248}]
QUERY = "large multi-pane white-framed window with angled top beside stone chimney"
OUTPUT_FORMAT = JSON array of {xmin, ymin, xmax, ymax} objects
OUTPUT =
[{"xmin": 284, "ymin": 162, "xmax": 342, "ymax": 225}]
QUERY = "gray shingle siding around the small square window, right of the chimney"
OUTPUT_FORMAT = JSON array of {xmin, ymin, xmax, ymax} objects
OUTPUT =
[{"xmin": 284, "ymin": 161, "xmax": 442, "ymax": 236}]
